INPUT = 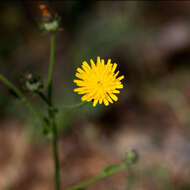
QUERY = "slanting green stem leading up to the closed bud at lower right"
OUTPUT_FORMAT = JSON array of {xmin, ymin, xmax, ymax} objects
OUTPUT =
[{"xmin": 68, "ymin": 163, "xmax": 127, "ymax": 190}]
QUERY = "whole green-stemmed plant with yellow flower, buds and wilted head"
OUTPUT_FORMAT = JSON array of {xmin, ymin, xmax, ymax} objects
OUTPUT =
[{"xmin": 0, "ymin": 4, "xmax": 137, "ymax": 190}]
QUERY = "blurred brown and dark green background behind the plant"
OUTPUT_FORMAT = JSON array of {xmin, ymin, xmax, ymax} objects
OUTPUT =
[{"xmin": 0, "ymin": 0, "xmax": 190, "ymax": 190}]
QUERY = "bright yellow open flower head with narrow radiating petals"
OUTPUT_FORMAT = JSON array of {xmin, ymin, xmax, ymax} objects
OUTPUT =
[{"xmin": 73, "ymin": 57, "xmax": 124, "ymax": 107}]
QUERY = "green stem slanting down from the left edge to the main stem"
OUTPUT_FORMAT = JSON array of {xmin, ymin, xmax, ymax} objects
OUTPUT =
[{"xmin": 0, "ymin": 74, "xmax": 48, "ymax": 127}]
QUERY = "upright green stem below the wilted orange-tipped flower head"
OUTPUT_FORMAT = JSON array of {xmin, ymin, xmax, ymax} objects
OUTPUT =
[{"xmin": 48, "ymin": 32, "xmax": 55, "ymax": 103}]
